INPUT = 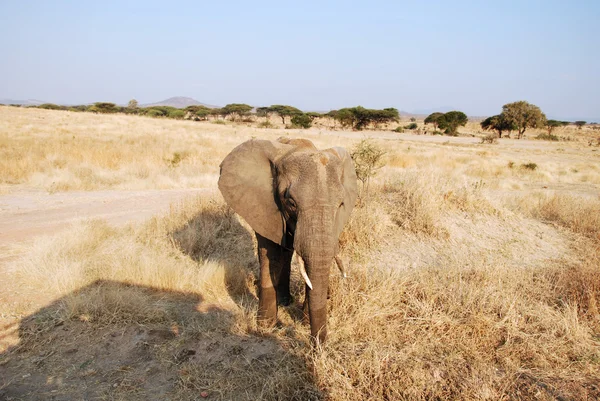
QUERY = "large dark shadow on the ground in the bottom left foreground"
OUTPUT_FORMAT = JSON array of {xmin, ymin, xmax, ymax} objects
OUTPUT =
[{"xmin": 0, "ymin": 281, "xmax": 323, "ymax": 400}]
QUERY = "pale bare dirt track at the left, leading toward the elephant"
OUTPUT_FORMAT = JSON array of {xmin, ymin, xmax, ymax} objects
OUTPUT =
[{"xmin": 0, "ymin": 188, "xmax": 209, "ymax": 350}]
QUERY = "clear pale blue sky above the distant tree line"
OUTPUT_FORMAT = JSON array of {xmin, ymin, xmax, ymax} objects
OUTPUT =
[{"xmin": 0, "ymin": 0, "xmax": 600, "ymax": 120}]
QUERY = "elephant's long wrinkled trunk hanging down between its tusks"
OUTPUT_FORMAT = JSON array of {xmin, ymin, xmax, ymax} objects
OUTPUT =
[{"xmin": 294, "ymin": 211, "xmax": 337, "ymax": 343}]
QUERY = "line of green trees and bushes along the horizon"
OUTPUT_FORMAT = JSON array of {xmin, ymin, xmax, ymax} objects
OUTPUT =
[{"xmin": 7, "ymin": 99, "xmax": 586, "ymax": 135}]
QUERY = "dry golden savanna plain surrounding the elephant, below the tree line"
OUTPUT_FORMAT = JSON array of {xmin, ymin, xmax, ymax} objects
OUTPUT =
[{"xmin": 0, "ymin": 106, "xmax": 600, "ymax": 400}]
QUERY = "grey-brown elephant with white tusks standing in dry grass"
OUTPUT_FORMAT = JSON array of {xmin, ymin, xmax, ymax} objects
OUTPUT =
[{"xmin": 219, "ymin": 138, "xmax": 357, "ymax": 344}]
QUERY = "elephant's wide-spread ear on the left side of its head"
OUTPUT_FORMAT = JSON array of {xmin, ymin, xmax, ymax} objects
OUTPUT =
[{"xmin": 219, "ymin": 139, "xmax": 293, "ymax": 244}]
